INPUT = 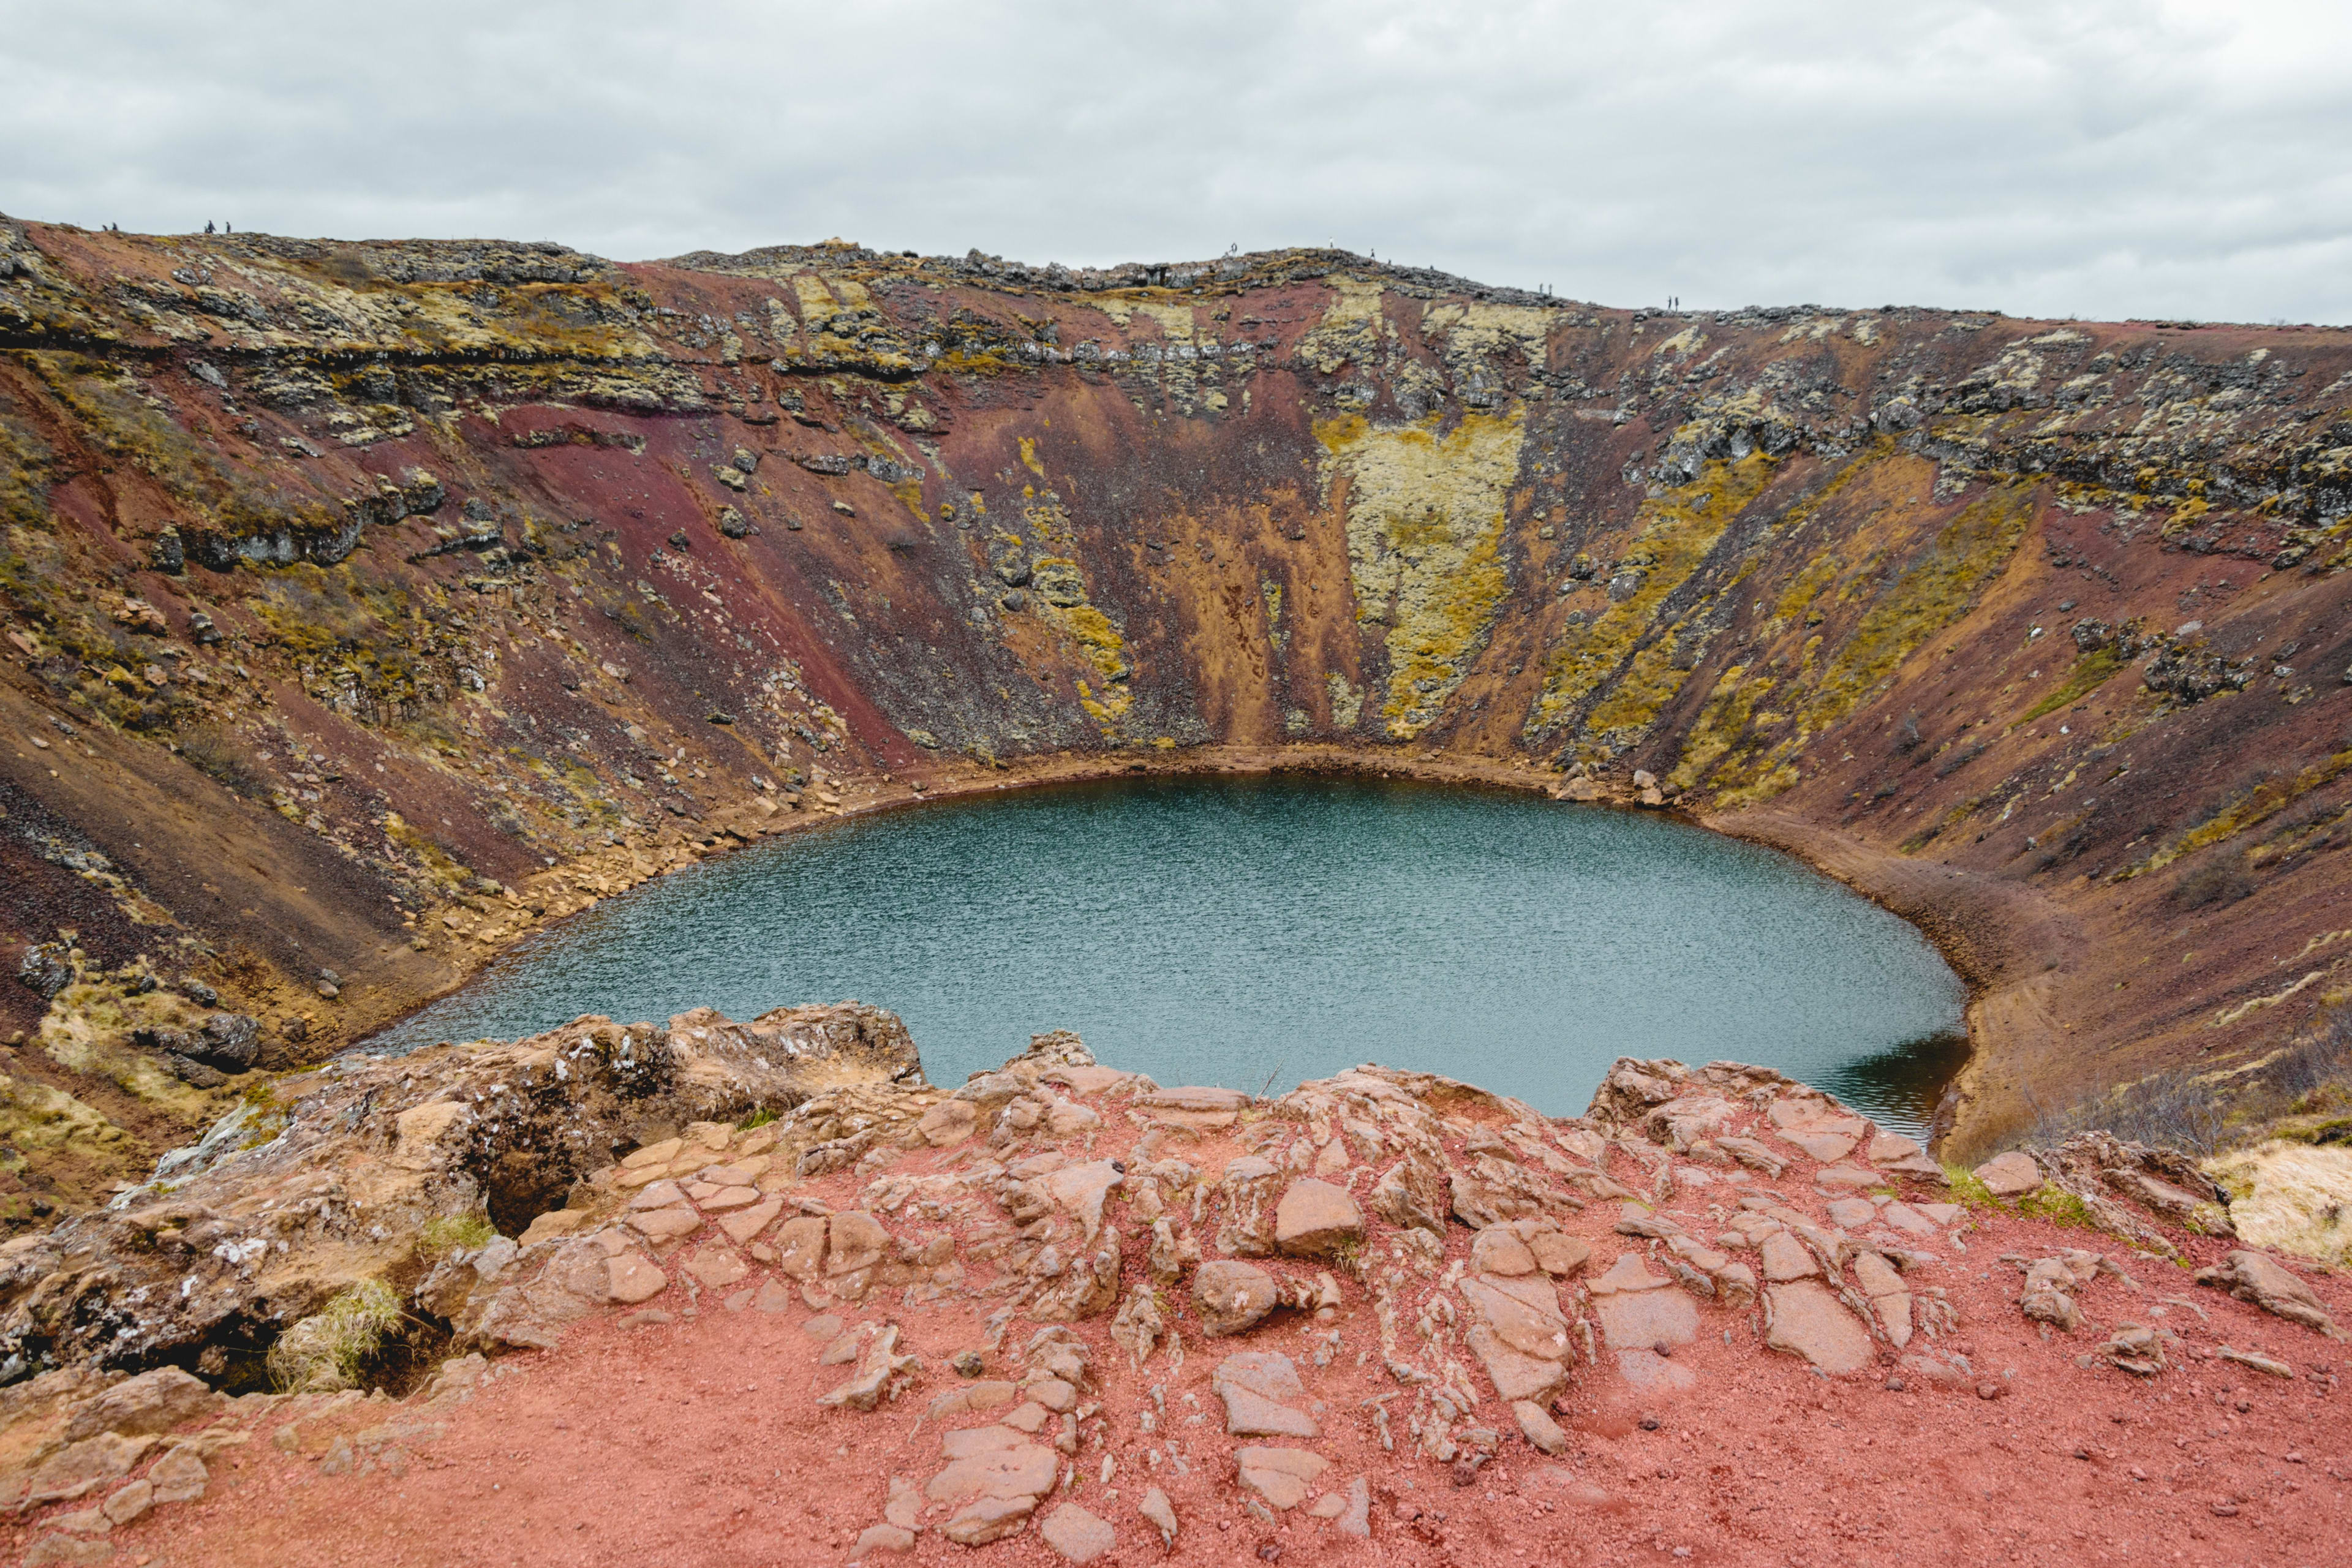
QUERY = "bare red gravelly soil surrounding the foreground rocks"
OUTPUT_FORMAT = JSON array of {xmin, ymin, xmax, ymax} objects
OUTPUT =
[{"xmin": 55, "ymin": 1104, "xmax": 2352, "ymax": 1568}]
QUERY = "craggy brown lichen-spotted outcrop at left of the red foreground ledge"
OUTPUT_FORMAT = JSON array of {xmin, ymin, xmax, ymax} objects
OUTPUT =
[{"xmin": 0, "ymin": 1004, "xmax": 922, "ymax": 1378}]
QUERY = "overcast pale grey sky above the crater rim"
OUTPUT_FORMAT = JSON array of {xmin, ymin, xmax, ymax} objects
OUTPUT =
[{"xmin": 0, "ymin": 0, "xmax": 2352, "ymax": 322}]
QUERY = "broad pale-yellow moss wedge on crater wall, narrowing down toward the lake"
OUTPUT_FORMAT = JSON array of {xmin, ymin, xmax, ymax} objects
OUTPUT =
[{"xmin": 1315, "ymin": 409, "xmax": 1524, "ymax": 741}]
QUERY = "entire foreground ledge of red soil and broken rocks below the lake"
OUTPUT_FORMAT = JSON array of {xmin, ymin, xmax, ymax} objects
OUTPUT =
[{"xmin": 0, "ymin": 1025, "xmax": 2352, "ymax": 1563}]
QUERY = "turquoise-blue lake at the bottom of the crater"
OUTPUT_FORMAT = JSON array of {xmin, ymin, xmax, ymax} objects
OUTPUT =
[{"xmin": 362, "ymin": 778, "xmax": 1964, "ymax": 1131}]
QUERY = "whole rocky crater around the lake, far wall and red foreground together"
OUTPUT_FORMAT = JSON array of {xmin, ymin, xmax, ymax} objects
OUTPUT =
[{"xmin": 0, "ymin": 219, "xmax": 2352, "ymax": 1561}]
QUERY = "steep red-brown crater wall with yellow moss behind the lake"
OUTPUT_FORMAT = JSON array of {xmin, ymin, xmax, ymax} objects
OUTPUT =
[{"xmin": 0, "ymin": 211, "xmax": 2352, "ymax": 1218}]
